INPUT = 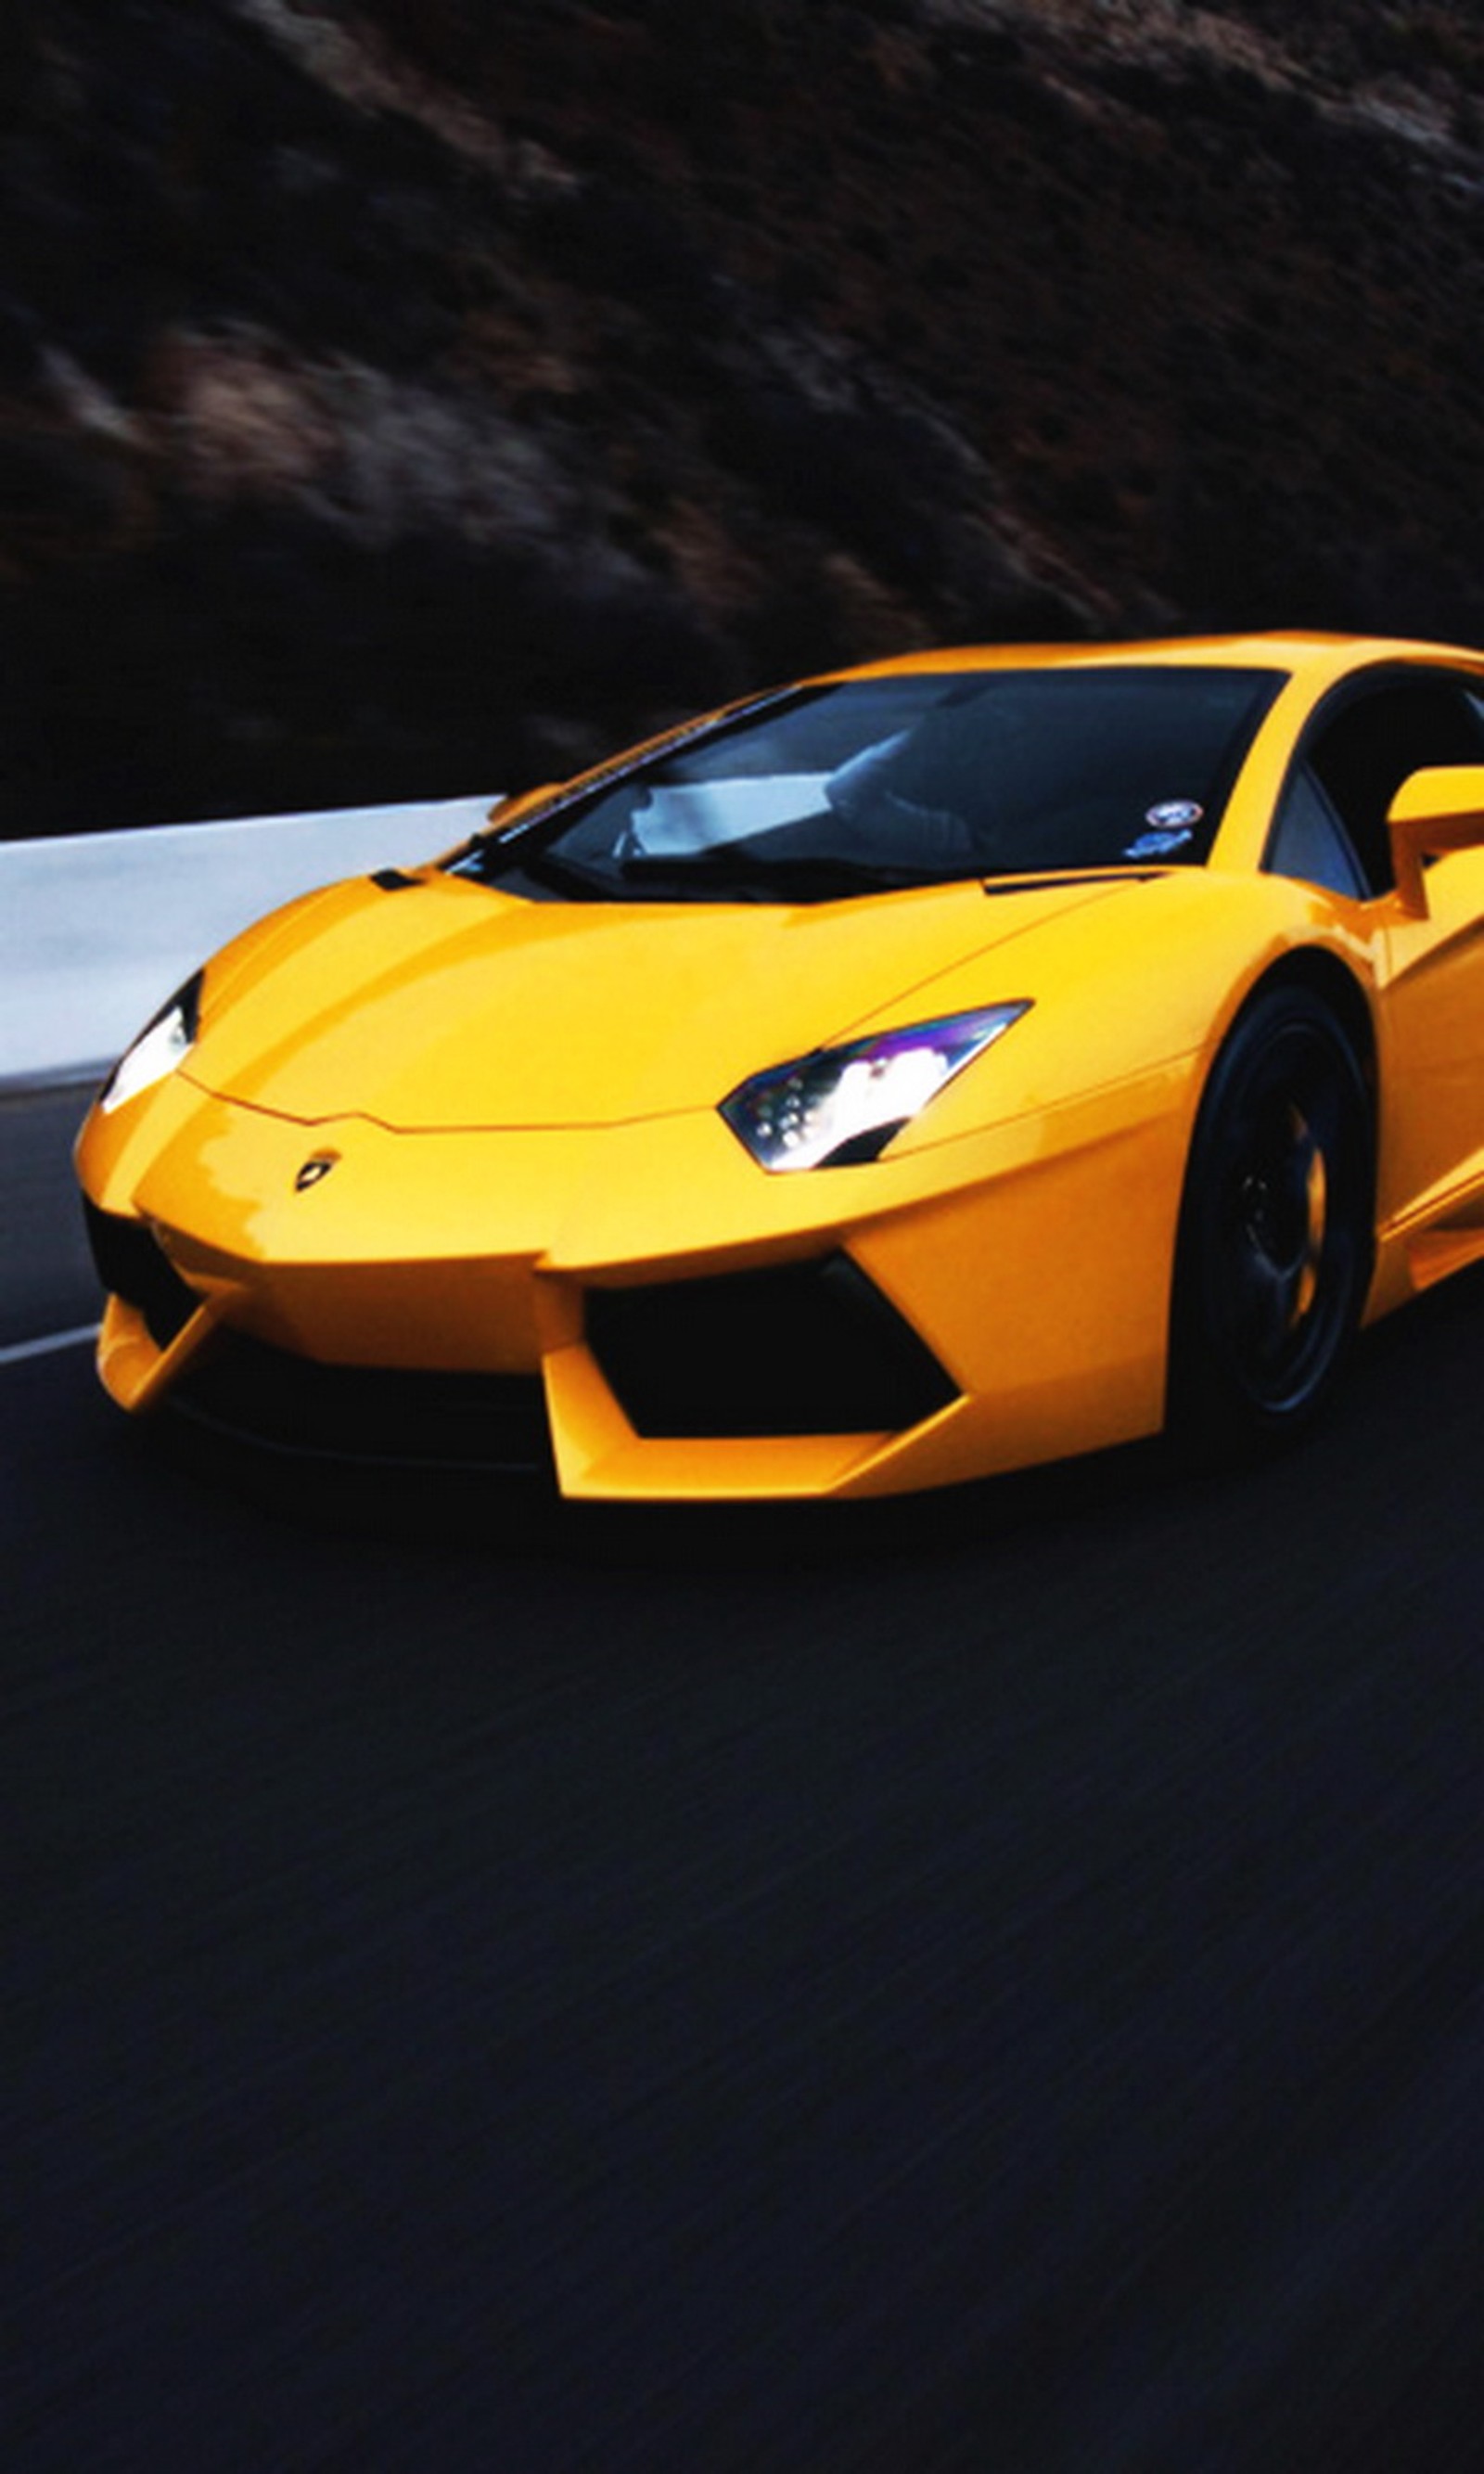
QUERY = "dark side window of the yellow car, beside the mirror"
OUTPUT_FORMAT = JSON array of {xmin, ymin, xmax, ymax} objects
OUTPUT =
[{"xmin": 1269, "ymin": 671, "xmax": 1484, "ymax": 893}]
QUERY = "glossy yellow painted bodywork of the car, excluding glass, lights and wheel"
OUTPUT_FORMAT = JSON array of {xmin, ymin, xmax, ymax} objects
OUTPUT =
[{"xmin": 79, "ymin": 635, "xmax": 1484, "ymax": 1497}]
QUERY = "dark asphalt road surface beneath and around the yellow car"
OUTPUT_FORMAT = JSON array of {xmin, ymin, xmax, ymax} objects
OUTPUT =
[{"xmin": 0, "ymin": 1103, "xmax": 1484, "ymax": 2474}]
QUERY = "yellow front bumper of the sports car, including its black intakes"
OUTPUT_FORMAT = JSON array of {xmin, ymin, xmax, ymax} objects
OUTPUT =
[{"xmin": 79, "ymin": 1069, "xmax": 1192, "ymax": 1499}]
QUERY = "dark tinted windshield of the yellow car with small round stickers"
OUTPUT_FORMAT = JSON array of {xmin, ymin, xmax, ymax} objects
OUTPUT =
[{"xmin": 453, "ymin": 663, "xmax": 1281, "ymax": 903}]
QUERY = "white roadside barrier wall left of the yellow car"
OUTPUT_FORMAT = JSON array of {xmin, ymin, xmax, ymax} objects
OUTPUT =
[{"xmin": 0, "ymin": 797, "xmax": 494, "ymax": 1091}]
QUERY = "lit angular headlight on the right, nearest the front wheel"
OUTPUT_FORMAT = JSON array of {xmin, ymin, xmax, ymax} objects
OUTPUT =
[{"xmin": 723, "ymin": 1005, "xmax": 1029, "ymax": 1168}]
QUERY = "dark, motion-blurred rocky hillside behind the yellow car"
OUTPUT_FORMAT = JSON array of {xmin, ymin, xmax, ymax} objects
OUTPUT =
[{"xmin": 0, "ymin": 0, "xmax": 1484, "ymax": 834}]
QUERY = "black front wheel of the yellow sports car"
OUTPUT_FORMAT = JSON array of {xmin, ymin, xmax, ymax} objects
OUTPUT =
[{"xmin": 1170, "ymin": 987, "xmax": 1375, "ymax": 1453}]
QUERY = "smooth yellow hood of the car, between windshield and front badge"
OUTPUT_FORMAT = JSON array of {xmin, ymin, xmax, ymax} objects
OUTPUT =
[{"xmin": 183, "ymin": 876, "xmax": 1125, "ymax": 1131}]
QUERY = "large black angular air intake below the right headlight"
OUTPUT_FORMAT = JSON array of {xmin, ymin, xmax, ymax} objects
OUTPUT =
[{"xmin": 586, "ymin": 1254, "xmax": 957, "ymax": 1438}]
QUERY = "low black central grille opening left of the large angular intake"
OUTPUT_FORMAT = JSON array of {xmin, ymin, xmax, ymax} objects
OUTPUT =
[{"xmin": 168, "ymin": 1328, "xmax": 552, "ymax": 1472}]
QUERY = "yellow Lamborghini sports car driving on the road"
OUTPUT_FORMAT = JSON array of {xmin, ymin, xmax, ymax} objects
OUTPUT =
[{"xmin": 79, "ymin": 635, "xmax": 1484, "ymax": 1497}]
